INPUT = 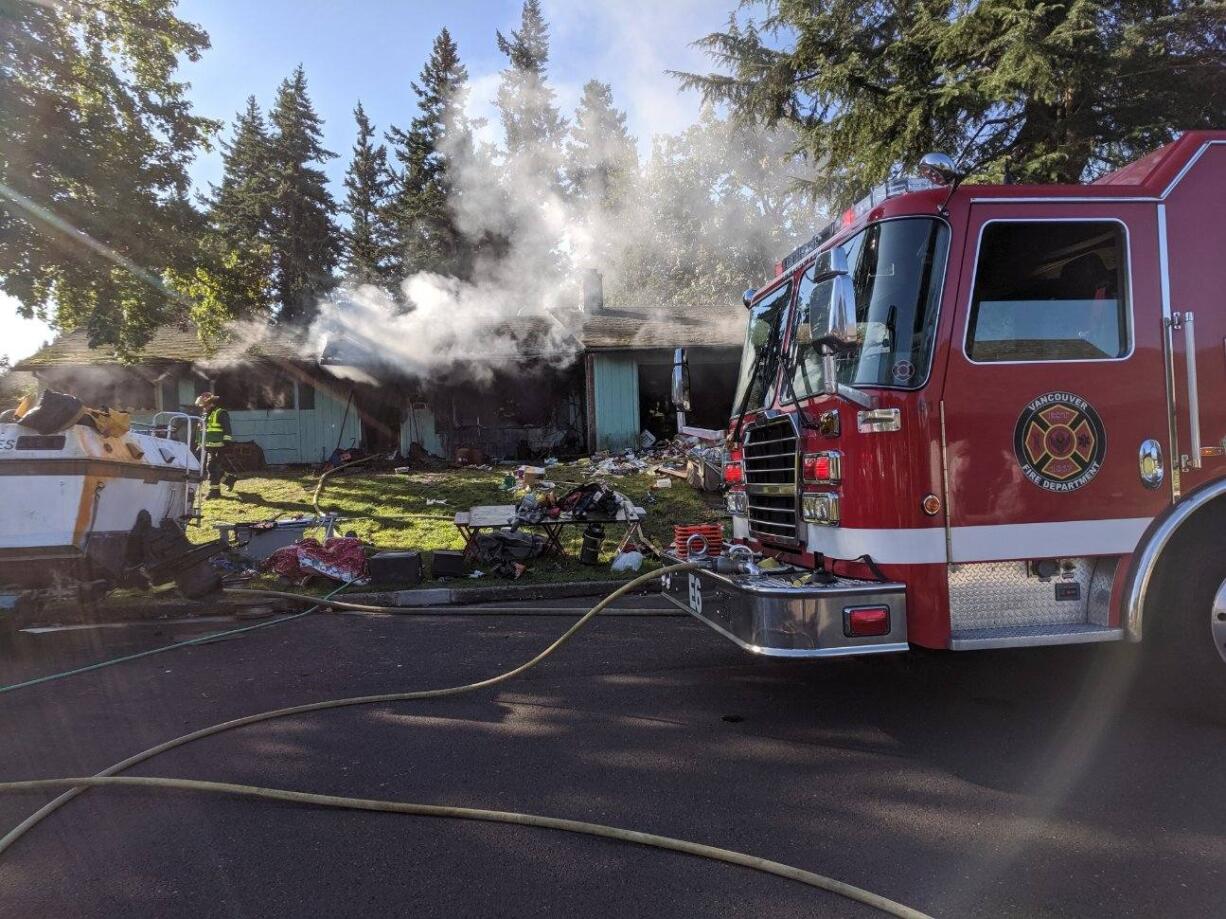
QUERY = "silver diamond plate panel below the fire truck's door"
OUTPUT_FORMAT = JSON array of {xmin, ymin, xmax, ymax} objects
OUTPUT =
[{"xmin": 949, "ymin": 559, "xmax": 1096, "ymax": 631}]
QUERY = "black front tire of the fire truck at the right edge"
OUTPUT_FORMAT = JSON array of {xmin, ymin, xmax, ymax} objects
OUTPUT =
[{"xmin": 1144, "ymin": 542, "xmax": 1226, "ymax": 714}]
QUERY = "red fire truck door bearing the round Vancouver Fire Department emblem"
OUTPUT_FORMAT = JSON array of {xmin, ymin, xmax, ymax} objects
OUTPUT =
[{"xmin": 943, "ymin": 201, "xmax": 1172, "ymax": 562}]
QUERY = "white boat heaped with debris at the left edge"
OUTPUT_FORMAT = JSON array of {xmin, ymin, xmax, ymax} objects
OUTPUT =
[{"xmin": 0, "ymin": 391, "xmax": 222, "ymax": 605}]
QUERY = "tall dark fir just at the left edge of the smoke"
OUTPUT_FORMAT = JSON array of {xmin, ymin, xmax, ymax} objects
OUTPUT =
[{"xmin": 387, "ymin": 28, "xmax": 473, "ymax": 277}]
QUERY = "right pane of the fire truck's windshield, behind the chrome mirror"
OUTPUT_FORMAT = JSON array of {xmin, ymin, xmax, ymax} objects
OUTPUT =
[{"xmin": 786, "ymin": 223, "xmax": 949, "ymax": 398}]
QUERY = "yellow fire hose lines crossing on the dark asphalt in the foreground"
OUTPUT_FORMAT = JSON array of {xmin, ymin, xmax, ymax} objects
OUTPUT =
[{"xmin": 0, "ymin": 565, "xmax": 924, "ymax": 919}]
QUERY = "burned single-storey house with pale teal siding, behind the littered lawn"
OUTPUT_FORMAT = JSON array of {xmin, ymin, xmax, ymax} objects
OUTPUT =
[{"xmin": 16, "ymin": 286, "xmax": 744, "ymax": 466}]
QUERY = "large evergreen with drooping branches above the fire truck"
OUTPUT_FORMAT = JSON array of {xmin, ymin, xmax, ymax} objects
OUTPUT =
[{"xmin": 678, "ymin": 0, "xmax": 1226, "ymax": 203}]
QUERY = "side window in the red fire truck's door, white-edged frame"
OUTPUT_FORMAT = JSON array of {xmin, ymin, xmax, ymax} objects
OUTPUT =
[{"xmin": 966, "ymin": 221, "xmax": 1130, "ymax": 363}]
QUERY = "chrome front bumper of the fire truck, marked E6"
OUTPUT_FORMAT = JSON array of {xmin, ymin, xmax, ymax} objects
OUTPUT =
[{"xmin": 662, "ymin": 558, "xmax": 907, "ymax": 658}]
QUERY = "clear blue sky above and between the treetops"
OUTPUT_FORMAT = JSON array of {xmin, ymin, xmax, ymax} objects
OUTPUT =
[{"xmin": 0, "ymin": 0, "xmax": 736, "ymax": 360}]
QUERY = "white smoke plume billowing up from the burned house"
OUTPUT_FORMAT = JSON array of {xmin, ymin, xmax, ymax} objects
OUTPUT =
[{"xmin": 309, "ymin": 62, "xmax": 818, "ymax": 381}]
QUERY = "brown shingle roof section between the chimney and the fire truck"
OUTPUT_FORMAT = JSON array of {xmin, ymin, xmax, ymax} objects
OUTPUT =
[{"xmin": 582, "ymin": 303, "xmax": 745, "ymax": 350}]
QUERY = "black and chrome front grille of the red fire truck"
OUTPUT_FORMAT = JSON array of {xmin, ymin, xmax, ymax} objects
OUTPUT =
[{"xmin": 744, "ymin": 418, "xmax": 797, "ymax": 542}]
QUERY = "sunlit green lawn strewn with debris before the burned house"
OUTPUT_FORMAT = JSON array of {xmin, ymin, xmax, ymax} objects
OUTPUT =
[{"xmin": 189, "ymin": 464, "xmax": 725, "ymax": 586}]
